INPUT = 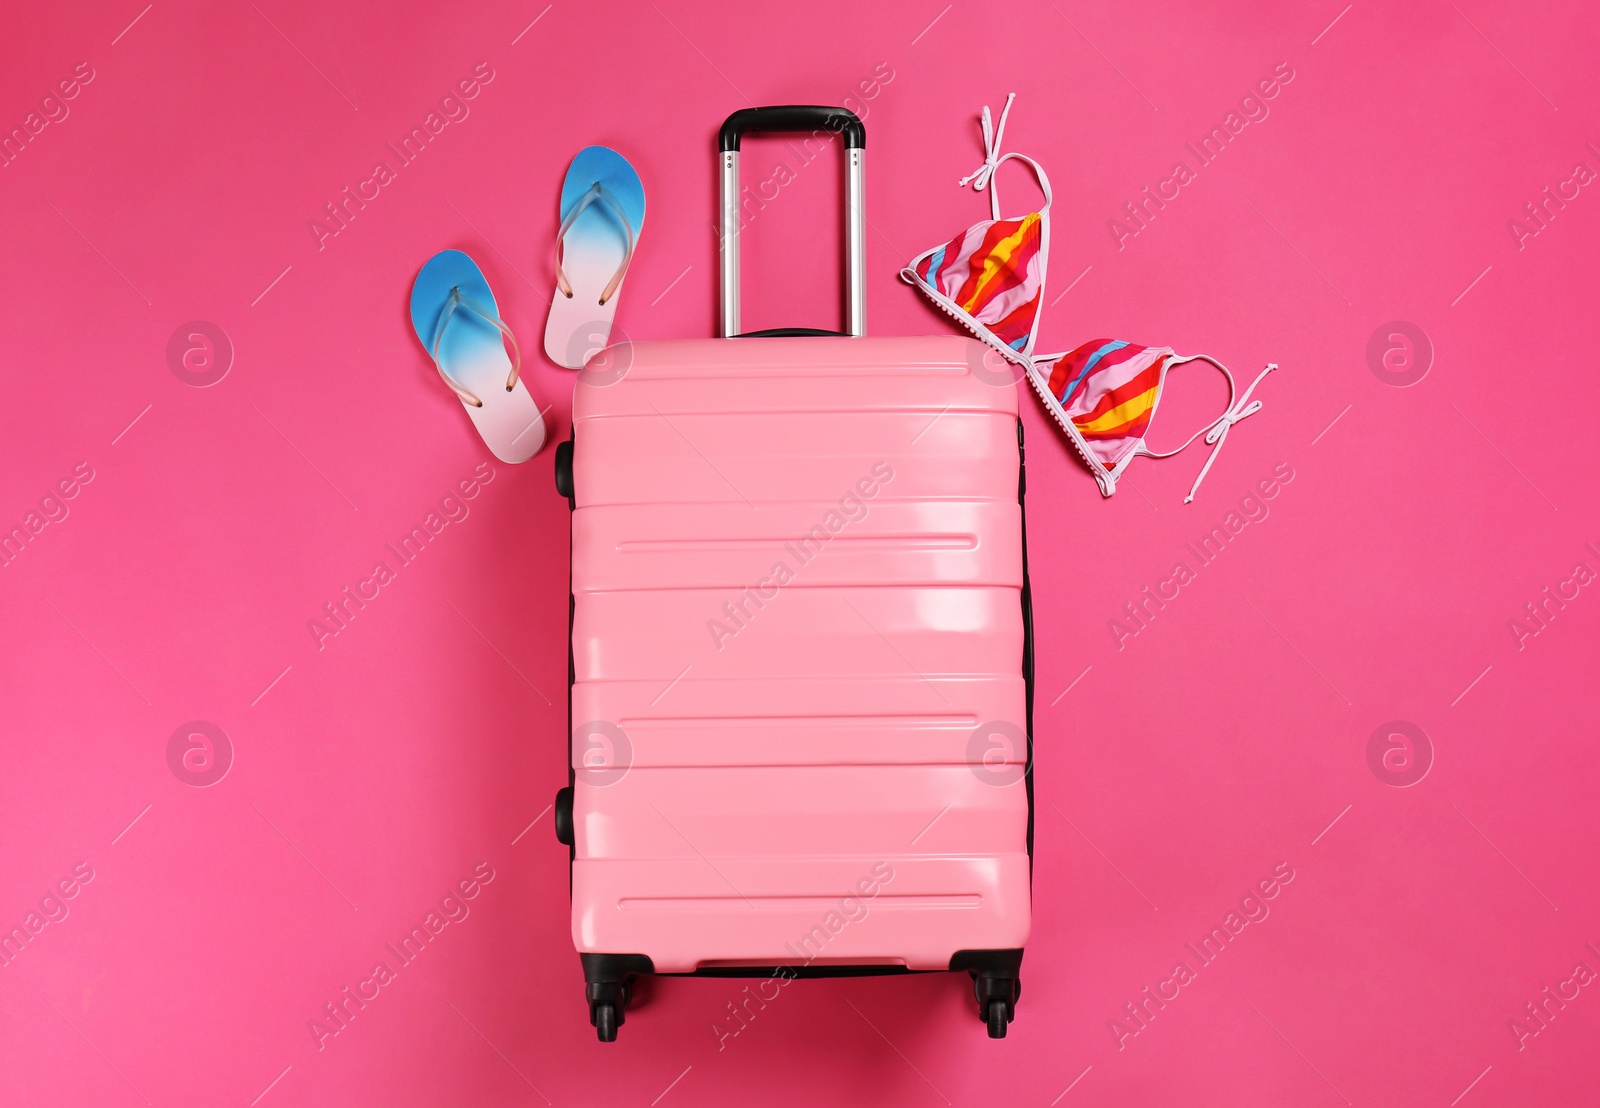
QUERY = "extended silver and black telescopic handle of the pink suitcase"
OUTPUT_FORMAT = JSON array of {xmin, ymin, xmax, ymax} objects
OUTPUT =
[{"xmin": 717, "ymin": 104, "xmax": 867, "ymax": 338}]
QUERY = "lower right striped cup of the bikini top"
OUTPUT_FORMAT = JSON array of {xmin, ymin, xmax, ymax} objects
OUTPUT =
[{"xmin": 1050, "ymin": 338, "xmax": 1173, "ymax": 469}]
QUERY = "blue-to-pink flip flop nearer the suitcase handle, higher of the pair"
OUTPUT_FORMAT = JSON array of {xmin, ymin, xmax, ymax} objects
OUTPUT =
[{"xmin": 544, "ymin": 146, "xmax": 645, "ymax": 370}]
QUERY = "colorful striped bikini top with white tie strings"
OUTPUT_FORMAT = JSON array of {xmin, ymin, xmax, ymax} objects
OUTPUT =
[{"xmin": 901, "ymin": 93, "xmax": 1278, "ymax": 504}]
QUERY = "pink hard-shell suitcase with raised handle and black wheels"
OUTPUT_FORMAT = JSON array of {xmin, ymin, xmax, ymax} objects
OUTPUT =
[{"xmin": 555, "ymin": 107, "xmax": 1032, "ymax": 1042}]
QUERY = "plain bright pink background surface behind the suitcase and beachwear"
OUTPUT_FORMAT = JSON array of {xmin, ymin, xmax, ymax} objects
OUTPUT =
[{"xmin": 0, "ymin": 0, "xmax": 1600, "ymax": 1108}]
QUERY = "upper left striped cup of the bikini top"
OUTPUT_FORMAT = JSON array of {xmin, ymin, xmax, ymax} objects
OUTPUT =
[{"xmin": 912, "ymin": 211, "xmax": 1045, "ymax": 345}]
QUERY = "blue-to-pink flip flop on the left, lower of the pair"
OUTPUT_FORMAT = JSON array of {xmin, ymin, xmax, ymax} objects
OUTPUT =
[{"xmin": 411, "ymin": 250, "xmax": 544, "ymax": 463}]
